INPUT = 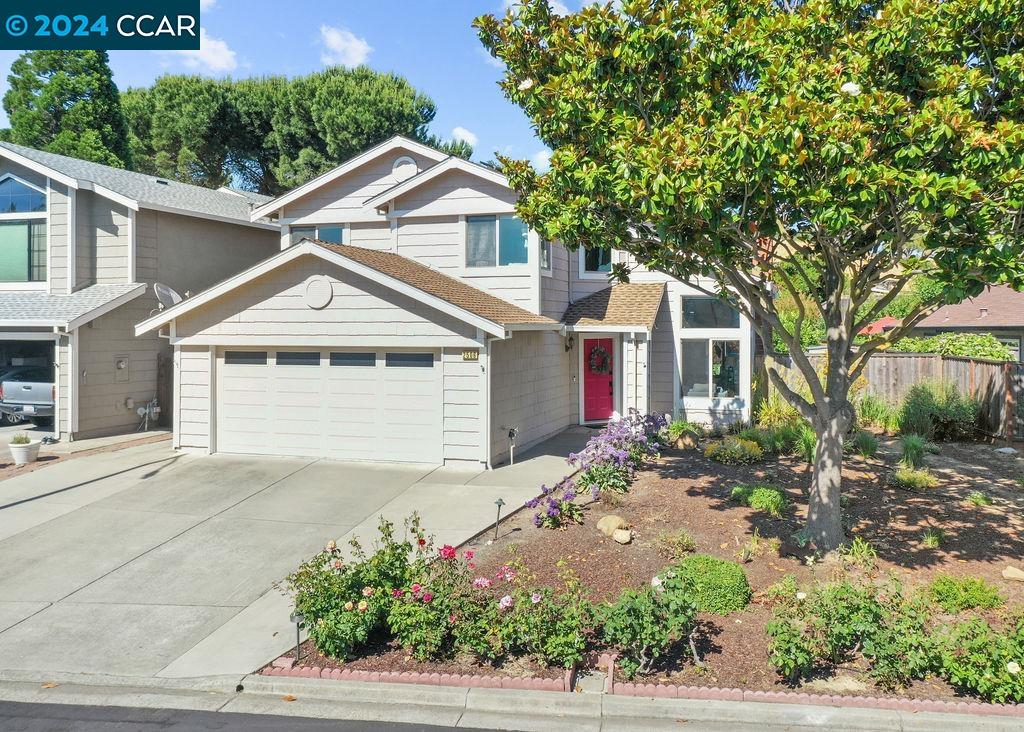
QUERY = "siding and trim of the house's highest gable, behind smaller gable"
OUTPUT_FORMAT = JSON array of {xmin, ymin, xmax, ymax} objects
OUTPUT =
[{"xmin": 282, "ymin": 149, "xmax": 434, "ymax": 224}]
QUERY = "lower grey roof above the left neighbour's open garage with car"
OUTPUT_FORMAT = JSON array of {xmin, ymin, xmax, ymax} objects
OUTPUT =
[{"xmin": 0, "ymin": 283, "xmax": 146, "ymax": 330}]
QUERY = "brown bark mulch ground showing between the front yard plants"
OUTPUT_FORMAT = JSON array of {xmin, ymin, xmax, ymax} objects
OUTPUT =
[{"xmin": 278, "ymin": 432, "xmax": 1024, "ymax": 700}]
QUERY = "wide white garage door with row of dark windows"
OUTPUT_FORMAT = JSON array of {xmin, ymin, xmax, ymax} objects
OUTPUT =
[{"xmin": 216, "ymin": 349, "xmax": 442, "ymax": 464}]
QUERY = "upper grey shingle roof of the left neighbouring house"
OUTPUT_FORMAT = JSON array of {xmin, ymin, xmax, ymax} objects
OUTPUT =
[{"xmin": 0, "ymin": 142, "xmax": 276, "ymax": 226}]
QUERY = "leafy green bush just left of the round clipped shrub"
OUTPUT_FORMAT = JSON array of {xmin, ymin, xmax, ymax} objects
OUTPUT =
[{"xmin": 600, "ymin": 576, "xmax": 696, "ymax": 679}]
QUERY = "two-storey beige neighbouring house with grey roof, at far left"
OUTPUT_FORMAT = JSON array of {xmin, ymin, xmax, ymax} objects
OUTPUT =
[{"xmin": 0, "ymin": 142, "xmax": 280, "ymax": 438}]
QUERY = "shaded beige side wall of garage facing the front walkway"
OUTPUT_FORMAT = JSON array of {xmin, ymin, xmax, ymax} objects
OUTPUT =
[{"xmin": 489, "ymin": 332, "xmax": 580, "ymax": 464}]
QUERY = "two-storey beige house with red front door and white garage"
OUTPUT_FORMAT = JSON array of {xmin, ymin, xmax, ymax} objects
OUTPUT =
[{"xmin": 136, "ymin": 137, "xmax": 753, "ymax": 467}]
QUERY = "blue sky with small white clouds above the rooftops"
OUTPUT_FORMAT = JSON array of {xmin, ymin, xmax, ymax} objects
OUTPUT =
[{"xmin": 0, "ymin": 0, "xmax": 582, "ymax": 169}]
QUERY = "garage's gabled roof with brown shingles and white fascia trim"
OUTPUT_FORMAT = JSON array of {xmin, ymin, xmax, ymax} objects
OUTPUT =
[{"xmin": 135, "ymin": 239, "xmax": 560, "ymax": 337}]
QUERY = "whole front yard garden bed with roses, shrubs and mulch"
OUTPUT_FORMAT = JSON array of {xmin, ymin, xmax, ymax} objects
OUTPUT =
[{"xmin": 278, "ymin": 403, "xmax": 1024, "ymax": 702}]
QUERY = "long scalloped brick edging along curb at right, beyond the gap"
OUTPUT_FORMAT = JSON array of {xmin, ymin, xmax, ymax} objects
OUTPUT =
[{"xmin": 595, "ymin": 653, "xmax": 1024, "ymax": 719}]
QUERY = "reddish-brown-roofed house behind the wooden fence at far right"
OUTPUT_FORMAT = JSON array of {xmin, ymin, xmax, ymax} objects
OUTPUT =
[{"xmin": 911, "ymin": 286, "xmax": 1024, "ymax": 361}]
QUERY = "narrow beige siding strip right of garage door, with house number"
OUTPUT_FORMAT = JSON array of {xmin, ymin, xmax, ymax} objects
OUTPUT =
[{"xmin": 441, "ymin": 348, "xmax": 486, "ymax": 462}]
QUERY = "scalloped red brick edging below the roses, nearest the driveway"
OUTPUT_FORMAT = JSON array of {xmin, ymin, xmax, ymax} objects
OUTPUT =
[{"xmin": 260, "ymin": 658, "xmax": 575, "ymax": 692}]
